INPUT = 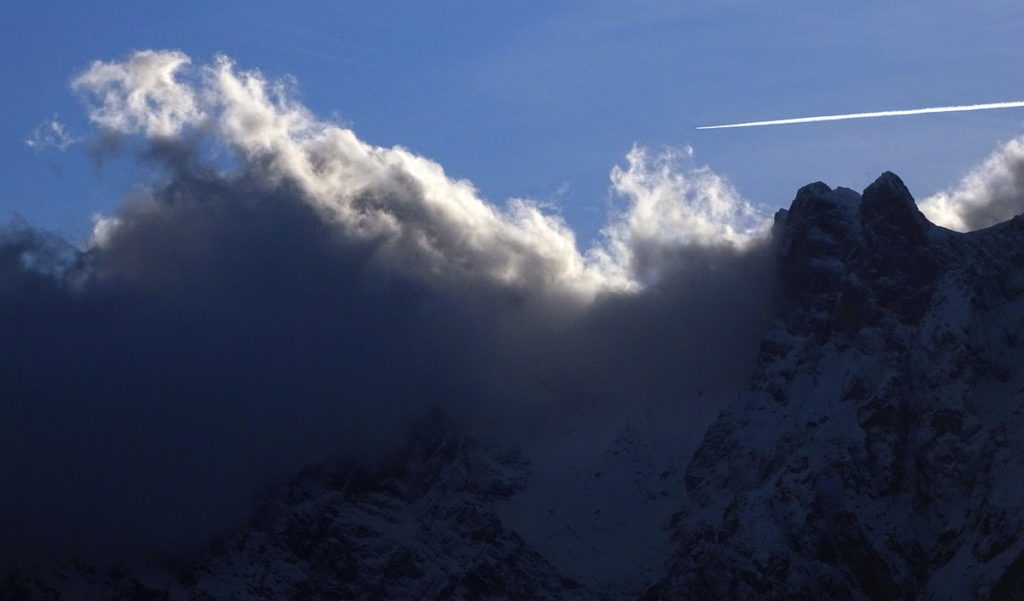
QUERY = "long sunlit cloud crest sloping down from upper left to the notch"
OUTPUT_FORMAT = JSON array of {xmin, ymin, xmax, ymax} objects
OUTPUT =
[{"xmin": 76, "ymin": 52, "xmax": 630, "ymax": 296}]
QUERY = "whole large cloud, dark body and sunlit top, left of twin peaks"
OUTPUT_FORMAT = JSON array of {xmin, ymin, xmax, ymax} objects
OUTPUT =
[{"xmin": 0, "ymin": 51, "xmax": 773, "ymax": 558}]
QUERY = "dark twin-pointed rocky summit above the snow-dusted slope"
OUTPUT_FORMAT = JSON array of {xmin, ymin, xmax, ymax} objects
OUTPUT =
[{"xmin": 774, "ymin": 172, "xmax": 947, "ymax": 333}]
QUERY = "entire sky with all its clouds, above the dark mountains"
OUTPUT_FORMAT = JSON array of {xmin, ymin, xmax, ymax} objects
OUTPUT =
[{"xmin": 6, "ymin": 2, "xmax": 1024, "ymax": 564}]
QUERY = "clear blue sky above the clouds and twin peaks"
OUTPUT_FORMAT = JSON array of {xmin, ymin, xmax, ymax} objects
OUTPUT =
[{"xmin": 0, "ymin": 1, "xmax": 1024, "ymax": 246}]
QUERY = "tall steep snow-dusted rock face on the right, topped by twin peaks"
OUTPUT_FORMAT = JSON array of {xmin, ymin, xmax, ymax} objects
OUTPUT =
[{"xmin": 643, "ymin": 173, "xmax": 1024, "ymax": 601}]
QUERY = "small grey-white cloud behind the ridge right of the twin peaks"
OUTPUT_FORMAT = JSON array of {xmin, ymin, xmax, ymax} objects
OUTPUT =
[{"xmin": 920, "ymin": 137, "xmax": 1024, "ymax": 231}]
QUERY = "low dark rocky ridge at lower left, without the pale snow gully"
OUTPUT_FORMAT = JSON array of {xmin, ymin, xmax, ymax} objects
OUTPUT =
[{"xmin": 0, "ymin": 433, "xmax": 597, "ymax": 601}]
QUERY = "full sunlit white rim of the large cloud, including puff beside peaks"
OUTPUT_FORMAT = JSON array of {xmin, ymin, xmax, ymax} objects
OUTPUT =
[{"xmin": 74, "ymin": 50, "xmax": 767, "ymax": 299}]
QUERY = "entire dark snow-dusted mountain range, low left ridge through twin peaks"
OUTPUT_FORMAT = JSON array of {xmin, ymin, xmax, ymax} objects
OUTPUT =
[{"xmin": 8, "ymin": 173, "xmax": 1024, "ymax": 601}]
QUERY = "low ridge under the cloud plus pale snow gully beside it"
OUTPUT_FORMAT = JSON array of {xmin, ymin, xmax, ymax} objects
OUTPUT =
[{"xmin": 0, "ymin": 423, "xmax": 696, "ymax": 601}]
